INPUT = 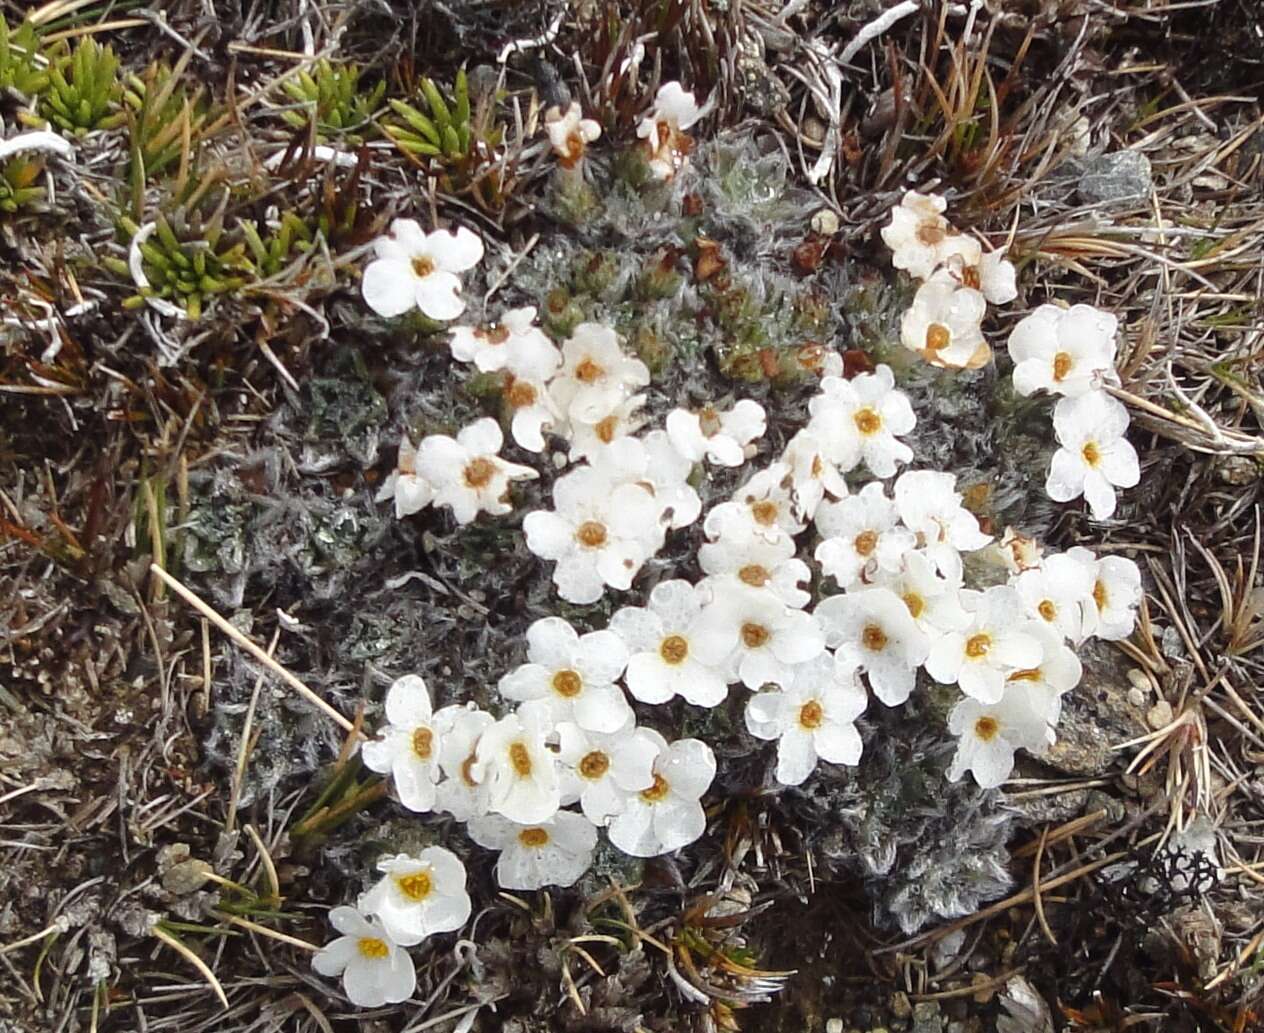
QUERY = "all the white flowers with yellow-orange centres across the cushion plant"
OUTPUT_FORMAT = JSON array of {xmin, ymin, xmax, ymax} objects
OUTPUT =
[{"xmin": 316, "ymin": 149, "xmax": 1141, "ymax": 1004}]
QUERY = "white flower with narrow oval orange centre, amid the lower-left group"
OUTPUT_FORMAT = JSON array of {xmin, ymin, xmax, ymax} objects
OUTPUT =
[{"xmin": 470, "ymin": 703, "xmax": 561, "ymax": 824}]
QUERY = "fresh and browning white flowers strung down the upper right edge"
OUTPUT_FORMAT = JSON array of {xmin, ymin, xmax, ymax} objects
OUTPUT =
[{"xmin": 882, "ymin": 191, "xmax": 1141, "ymax": 520}]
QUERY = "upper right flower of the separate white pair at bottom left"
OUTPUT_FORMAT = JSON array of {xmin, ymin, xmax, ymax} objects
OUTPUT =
[{"xmin": 359, "ymin": 846, "xmax": 470, "ymax": 947}]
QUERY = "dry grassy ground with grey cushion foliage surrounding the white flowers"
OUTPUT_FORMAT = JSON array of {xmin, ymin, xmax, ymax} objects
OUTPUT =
[{"xmin": 0, "ymin": 0, "xmax": 1264, "ymax": 1033}]
